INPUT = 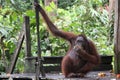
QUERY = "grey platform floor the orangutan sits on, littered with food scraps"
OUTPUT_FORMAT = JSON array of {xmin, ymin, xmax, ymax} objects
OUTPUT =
[{"xmin": 0, "ymin": 71, "xmax": 119, "ymax": 80}]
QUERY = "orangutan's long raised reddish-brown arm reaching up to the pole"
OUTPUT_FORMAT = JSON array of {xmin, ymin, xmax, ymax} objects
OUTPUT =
[{"xmin": 35, "ymin": 3, "xmax": 76, "ymax": 40}]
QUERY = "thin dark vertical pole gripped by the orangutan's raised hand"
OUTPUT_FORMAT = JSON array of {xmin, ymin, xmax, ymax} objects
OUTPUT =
[{"xmin": 34, "ymin": 0, "xmax": 45, "ymax": 80}]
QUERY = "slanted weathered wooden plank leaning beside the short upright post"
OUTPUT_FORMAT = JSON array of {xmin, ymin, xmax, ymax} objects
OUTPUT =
[{"xmin": 8, "ymin": 28, "xmax": 24, "ymax": 74}]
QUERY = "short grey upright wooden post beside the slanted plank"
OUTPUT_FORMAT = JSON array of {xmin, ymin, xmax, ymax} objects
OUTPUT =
[{"xmin": 24, "ymin": 16, "xmax": 35, "ymax": 73}]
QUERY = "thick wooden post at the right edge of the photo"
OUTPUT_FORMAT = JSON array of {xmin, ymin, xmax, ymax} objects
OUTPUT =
[{"xmin": 114, "ymin": 0, "xmax": 120, "ymax": 74}]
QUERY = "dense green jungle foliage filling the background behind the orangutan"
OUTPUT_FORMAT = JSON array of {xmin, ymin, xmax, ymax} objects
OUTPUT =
[{"xmin": 0, "ymin": 0, "xmax": 114, "ymax": 73}]
